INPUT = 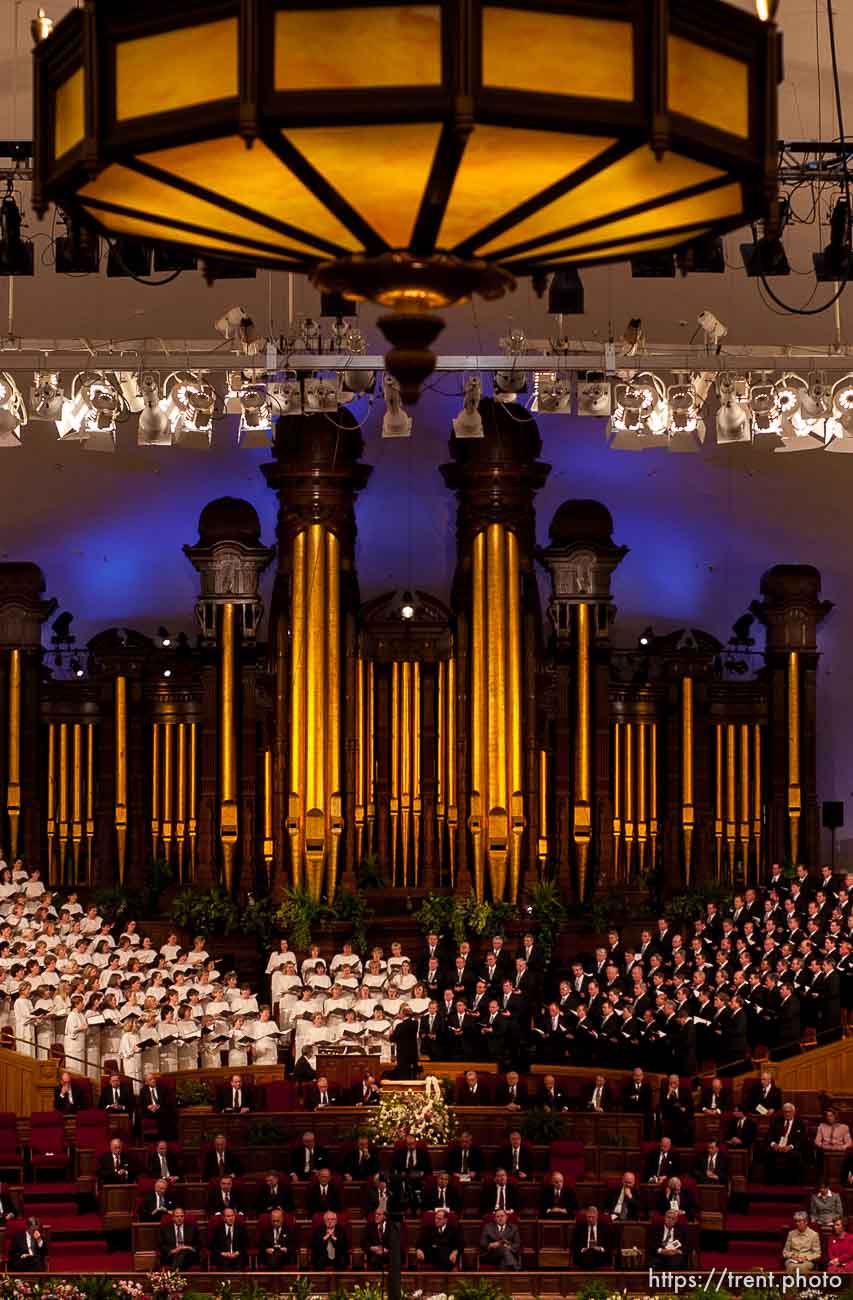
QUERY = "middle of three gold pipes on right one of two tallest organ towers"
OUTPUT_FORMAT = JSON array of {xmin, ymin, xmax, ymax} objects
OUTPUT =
[{"xmin": 484, "ymin": 524, "xmax": 510, "ymax": 898}]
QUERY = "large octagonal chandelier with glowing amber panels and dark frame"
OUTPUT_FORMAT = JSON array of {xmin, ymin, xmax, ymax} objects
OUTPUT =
[{"xmin": 34, "ymin": 0, "xmax": 780, "ymax": 392}]
